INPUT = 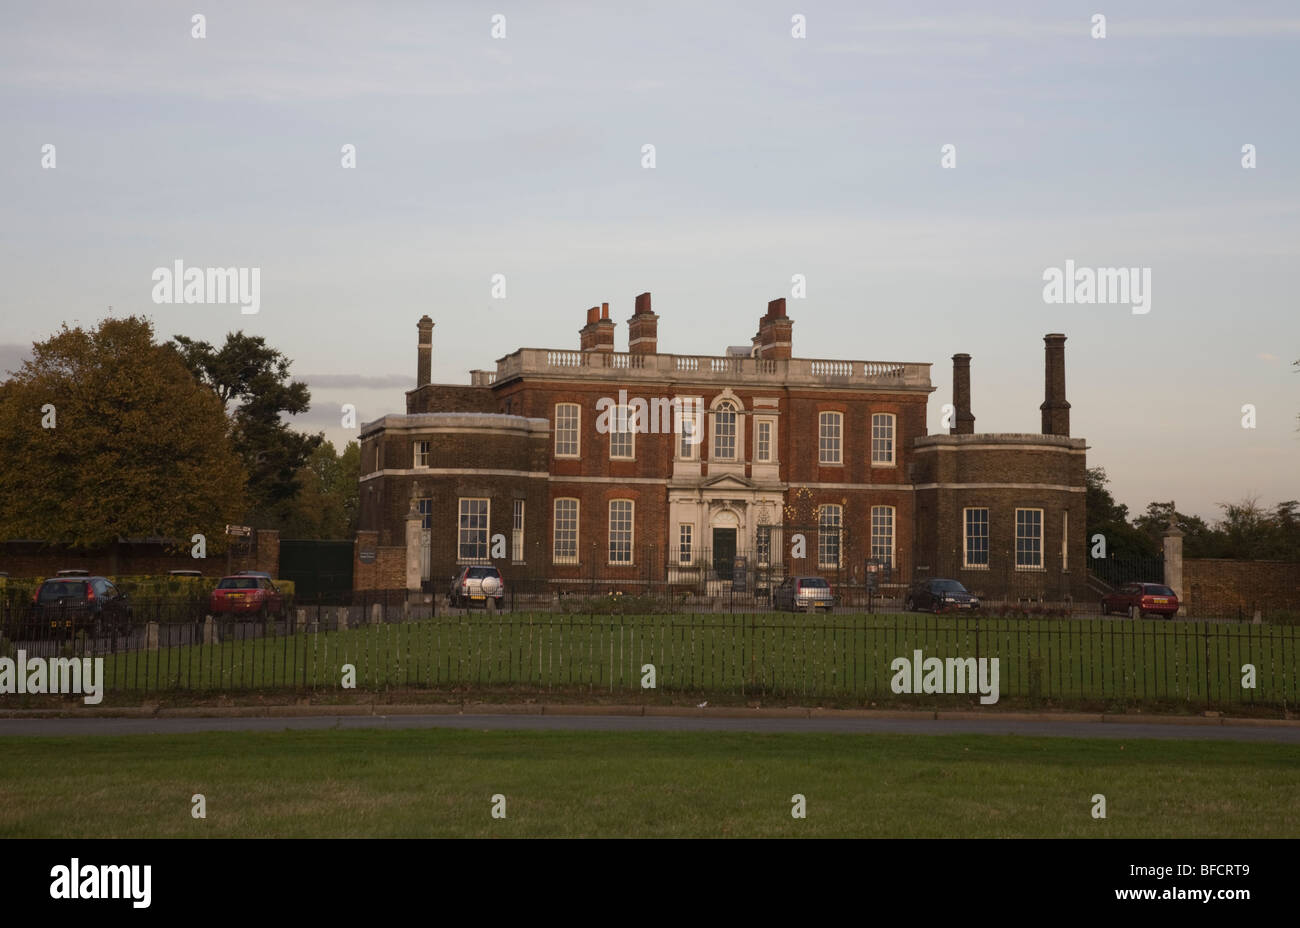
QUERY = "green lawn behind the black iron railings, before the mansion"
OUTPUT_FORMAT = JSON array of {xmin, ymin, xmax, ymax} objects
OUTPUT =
[{"xmin": 86, "ymin": 613, "xmax": 1300, "ymax": 706}]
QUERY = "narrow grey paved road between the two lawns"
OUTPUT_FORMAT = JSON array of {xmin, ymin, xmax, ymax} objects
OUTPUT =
[{"xmin": 0, "ymin": 715, "xmax": 1300, "ymax": 745}]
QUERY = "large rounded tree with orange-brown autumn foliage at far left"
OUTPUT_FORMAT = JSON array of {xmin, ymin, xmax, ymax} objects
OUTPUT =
[{"xmin": 0, "ymin": 316, "xmax": 246, "ymax": 552}]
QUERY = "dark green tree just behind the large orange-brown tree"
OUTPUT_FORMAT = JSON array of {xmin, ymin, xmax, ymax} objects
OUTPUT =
[{"xmin": 173, "ymin": 331, "xmax": 325, "ymax": 522}]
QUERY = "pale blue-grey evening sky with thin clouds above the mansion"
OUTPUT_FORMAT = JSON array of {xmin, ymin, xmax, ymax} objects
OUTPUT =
[{"xmin": 0, "ymin": 0, "xmax": 1300, "ymax": 519}]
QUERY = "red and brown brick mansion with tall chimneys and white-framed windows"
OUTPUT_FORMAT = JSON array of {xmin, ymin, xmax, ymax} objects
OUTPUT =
[{"xmin": 356, "ymin": 294, "xmax": 1087, "ymax": 595}]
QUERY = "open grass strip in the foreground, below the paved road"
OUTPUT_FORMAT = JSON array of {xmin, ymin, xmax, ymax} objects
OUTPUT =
[{"xmin": 0, "ymin": 729, "xmax": 1300, "ymax": 837}]
